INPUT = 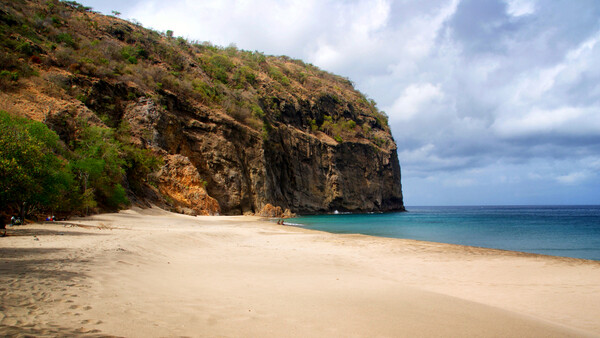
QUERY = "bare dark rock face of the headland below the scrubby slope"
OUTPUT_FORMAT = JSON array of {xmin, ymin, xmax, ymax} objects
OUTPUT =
[{"xmin": 125, "ymin": 89, "xmax": 403, "ymax": 214}]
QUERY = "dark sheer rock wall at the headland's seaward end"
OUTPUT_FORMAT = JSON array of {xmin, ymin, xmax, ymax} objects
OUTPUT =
[{"xmin": 264, "ymin": 126, "xmax": 402, "ymax": 212}]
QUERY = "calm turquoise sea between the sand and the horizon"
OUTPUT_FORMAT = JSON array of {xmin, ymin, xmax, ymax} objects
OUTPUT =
[{"xmin": 290, "ymin": 206, "xmax": 600, "ymax": 261}]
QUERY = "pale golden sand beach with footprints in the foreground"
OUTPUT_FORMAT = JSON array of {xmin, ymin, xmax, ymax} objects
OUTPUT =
[{"xmin": 0, "ymin": 209, "xmax": 600, "ymax": 337}]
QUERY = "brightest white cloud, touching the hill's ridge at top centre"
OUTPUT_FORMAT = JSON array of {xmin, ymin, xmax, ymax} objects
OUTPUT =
[{"xmin": 127, "ymin": 0, "xmax": 326, "ymax": 57}]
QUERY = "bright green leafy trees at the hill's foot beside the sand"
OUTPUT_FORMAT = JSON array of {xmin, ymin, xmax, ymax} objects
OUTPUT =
[{"xmin": 0, "ymin": 111, "xmax": 162, "ymax": 217}]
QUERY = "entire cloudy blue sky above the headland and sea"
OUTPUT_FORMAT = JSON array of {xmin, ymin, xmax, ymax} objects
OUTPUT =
[{"xmin": 79, "ymin": 0, "xmax": 600, "ymax": 206}]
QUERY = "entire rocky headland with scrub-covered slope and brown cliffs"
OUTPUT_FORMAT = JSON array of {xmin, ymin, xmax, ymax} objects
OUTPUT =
[{"xmin": 0, "ymin": 1, "xmax": 404, "ymax": 214}]
